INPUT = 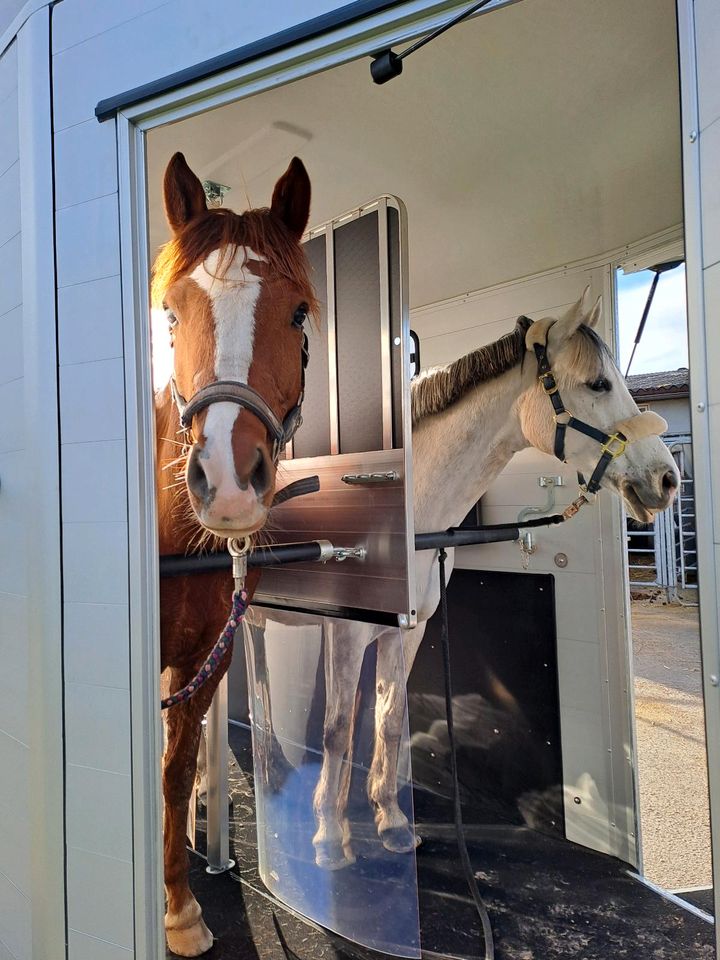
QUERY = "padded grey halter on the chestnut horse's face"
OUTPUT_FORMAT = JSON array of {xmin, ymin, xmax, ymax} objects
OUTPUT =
[{"xmin": 170, "ymin": 333, "xmax": 310, "ymax": 463}]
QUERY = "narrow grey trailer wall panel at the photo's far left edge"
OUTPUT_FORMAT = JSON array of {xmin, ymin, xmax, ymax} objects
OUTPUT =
[{"xmin": 0, "ymin": 35, "xmax": 31, "ymax": 960}]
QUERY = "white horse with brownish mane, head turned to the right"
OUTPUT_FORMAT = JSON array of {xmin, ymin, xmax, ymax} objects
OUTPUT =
[{"xmin": 313, "ymin": 288, "xmax": 679, "ymax": 869}]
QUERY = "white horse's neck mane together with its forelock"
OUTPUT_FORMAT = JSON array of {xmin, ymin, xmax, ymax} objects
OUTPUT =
[{"xmin": 410, "ymin": 317, "xmax": 614, "ymax": 424}]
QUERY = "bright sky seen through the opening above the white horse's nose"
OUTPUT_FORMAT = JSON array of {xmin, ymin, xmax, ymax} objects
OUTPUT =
[{"xmin": 618, "ymin": 264, "xmax": 688, "ymax": 374}]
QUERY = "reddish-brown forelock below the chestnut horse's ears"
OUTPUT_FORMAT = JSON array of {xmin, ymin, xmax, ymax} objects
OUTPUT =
[{"xmin": 151, "ymin": 207, "xmax": 316, "ymax": 313}]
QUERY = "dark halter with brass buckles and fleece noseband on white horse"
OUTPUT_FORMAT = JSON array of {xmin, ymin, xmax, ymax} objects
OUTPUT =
[{"xmin": 533, "ymin": 320, "xmax": 667, "ymax": 516}]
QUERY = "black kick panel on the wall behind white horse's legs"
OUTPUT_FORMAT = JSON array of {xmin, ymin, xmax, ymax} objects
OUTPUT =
[{"xmin": 408, "ymin": 569, "xmax": 564, "ymax": 836}]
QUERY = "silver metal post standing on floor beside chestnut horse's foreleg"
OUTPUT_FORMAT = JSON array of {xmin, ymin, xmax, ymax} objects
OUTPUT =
[{"xmin": 207, "ymin": 674, "xmax": 235, "ymax": 873}]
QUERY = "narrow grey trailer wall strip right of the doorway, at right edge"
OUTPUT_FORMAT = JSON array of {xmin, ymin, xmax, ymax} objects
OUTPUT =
[{"xmin": 677, "ymin": 0, "xmax": 720, "ymax": 951}]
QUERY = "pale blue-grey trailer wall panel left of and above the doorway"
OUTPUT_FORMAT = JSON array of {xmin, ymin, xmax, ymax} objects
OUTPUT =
[{"xmin": 50, "ymin": 0, "xmax": 390, "ymax": 960}]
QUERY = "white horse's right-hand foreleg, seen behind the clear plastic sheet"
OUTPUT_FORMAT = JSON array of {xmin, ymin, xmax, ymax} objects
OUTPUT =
[{"xmin": 368, "ymin": 624, "xmax": 425, "ymax": 853}]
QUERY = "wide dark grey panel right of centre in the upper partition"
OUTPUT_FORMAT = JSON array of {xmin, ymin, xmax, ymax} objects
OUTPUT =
[{"xmin": 335, "ymin": 212, "xmax": 383, "ymax": 453}]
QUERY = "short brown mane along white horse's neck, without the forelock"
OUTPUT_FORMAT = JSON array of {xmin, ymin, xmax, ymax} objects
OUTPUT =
[{"xmin": 410, "ymin": 317, "xmax": 532, "ymax": 424}]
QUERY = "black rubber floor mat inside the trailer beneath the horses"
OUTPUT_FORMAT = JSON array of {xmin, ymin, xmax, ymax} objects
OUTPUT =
[{"xmin": 168, "ymin": 727, "xmax": 715, "ymax": 960}]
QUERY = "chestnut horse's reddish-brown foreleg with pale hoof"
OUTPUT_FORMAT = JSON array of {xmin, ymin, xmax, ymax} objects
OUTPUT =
[{"xmin": 163, "ymin": 665, "xmax": 227, "ymax": 957}]
